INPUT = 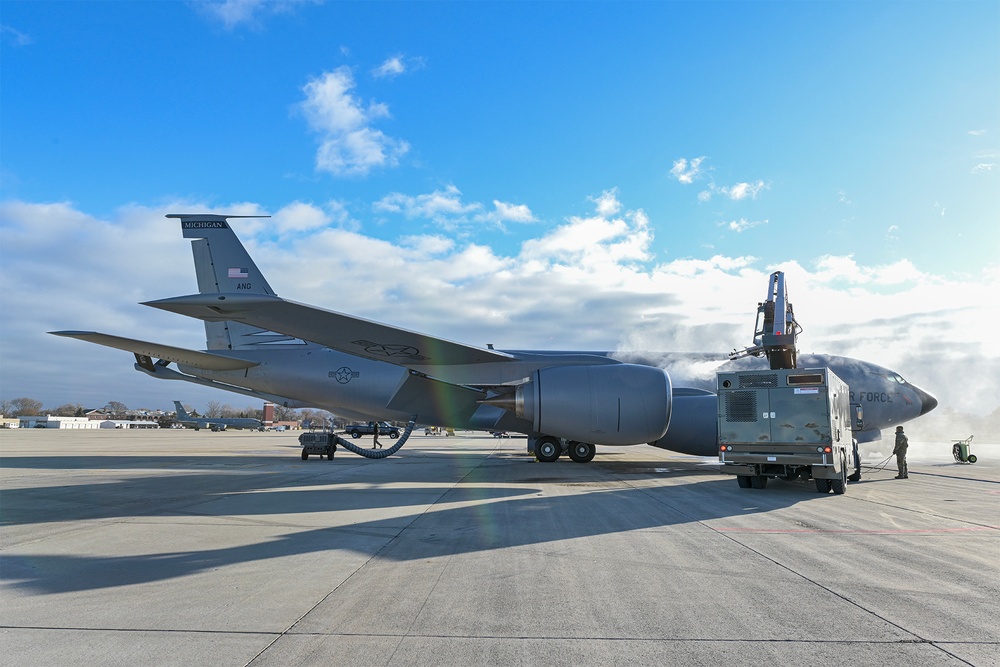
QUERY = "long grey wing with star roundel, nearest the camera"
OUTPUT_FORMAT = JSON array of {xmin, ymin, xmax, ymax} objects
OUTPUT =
[{"xmin": 143, "ymin": 293, "xmax": 517, "ymax": 368}]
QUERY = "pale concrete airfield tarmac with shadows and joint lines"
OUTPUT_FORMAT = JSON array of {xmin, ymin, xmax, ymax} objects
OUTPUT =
[{"xmin": 0, "ymin": 425, "xmax": 1000, "ymax": 667}]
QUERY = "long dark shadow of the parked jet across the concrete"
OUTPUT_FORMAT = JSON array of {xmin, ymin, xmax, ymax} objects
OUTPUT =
[{"xmin": 0, "ymin": 453, "xmax": 812, "ymax": 594}]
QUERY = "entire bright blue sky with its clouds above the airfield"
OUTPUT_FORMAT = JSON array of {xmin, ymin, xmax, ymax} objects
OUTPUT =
[{"xmin": 0, "ymin": 0, "xmax": 1000, "ymax": 422}]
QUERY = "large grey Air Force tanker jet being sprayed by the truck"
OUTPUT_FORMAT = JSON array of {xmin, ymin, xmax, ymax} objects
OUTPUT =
[{"xmin": 52, "ymin": 214, "xmax": 937, "ymax": 462}]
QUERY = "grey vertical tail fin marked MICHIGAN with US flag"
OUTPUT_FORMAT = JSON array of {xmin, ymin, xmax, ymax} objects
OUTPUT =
[{"xmin": 167, "ymin": 213, "xmax": 302, "ymax": 350}]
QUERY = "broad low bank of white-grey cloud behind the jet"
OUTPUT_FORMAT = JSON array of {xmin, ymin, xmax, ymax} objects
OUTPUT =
[{"xmin": 0, "ymin": 198, "xmax": 1000, "ymax": 414}]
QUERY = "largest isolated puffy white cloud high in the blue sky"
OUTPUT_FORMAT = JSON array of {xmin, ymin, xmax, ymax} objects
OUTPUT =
[{"xmin": 299, "ymin": 66, "xmax": 410, "ymax": 176}]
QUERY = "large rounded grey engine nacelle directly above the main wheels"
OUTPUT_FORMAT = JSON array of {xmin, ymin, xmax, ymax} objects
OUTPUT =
[{"xmin": 514, "ymin": 364, "xmax": 671, "ymax": 445}]
